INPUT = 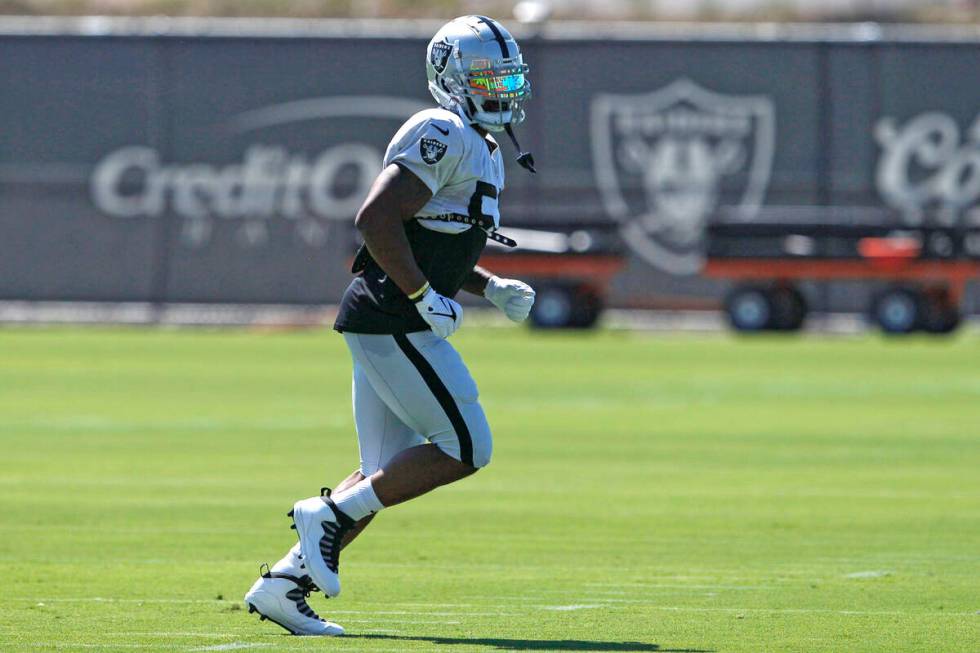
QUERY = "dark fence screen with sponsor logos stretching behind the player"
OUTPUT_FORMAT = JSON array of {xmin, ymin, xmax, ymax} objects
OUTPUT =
[{"xmin": 0, "ymin": 21, "xmax": 980, "ymax": 306}]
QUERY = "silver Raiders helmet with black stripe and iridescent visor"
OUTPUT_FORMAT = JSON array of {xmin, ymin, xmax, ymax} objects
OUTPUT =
[{"xmin": 425, "ymin": 16, "xmax": 531, "ymax": 131}]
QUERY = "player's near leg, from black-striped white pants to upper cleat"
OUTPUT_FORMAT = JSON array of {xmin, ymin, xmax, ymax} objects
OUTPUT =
[{"xmin": 291, "ymin": 331, "xmax": 492, "ymax": 596}]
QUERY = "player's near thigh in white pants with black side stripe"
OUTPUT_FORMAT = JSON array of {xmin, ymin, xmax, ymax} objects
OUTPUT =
[{"xmin": 345, "ymin": 331, "xmax": 493, "ymax": 467}]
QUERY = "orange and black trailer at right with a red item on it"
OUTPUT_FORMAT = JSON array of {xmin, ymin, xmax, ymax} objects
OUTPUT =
[{"xmin": 704, "ymin": 222, "xmax": 980, "ymax": 334}]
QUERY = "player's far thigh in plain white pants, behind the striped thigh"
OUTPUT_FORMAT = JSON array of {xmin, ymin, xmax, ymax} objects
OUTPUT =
[{"xmin": 352, "ymin": 359, "xmax": 425, "ymax": 476}]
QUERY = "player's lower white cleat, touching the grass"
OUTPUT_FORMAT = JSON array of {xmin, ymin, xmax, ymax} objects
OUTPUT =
[{"xmin": 245, "ymin": 570, "xmax": 344, "ymax": 636}]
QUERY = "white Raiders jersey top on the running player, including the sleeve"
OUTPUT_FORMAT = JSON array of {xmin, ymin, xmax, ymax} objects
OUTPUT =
[{"xmin": 384, "ymin": 109, "xmax": 504, "ymax": 233}]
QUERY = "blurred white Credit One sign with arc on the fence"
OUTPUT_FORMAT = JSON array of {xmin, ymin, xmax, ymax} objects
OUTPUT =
[{"xmin": 90, "ymin": 96, "xmax": 428, "ymax": 246}]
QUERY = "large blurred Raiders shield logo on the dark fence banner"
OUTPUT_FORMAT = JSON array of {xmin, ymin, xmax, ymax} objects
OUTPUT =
[{"xmin": 592, "ymin": 79, "xmax": 775, "ymax": 274}]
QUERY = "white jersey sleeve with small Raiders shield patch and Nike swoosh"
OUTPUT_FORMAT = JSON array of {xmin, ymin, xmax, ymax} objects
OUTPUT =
[{"xmin": 389, "ymin": 119, "xmax": 463, "ymax": 195}]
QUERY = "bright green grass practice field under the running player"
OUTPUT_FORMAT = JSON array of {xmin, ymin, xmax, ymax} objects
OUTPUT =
[{"xmin": 0, "ymin": 328, "xmax": 980, "ymax": 653}]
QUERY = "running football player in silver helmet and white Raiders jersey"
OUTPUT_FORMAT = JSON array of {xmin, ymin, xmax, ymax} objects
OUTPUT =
[{"xmin": 245, "ymin": 16, "xmax": 534, "ymax": 635}]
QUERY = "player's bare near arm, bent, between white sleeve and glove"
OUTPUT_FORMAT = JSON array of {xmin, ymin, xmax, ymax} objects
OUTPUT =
[{"xmin": 354, "ymin": 163, "xmax": 432, "ymax": 296}]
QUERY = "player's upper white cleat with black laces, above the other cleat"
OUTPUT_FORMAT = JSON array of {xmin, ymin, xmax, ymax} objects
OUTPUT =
[{"xmin": 288, "ymin": 496, "xmax": 354, "ymax": 597}]
